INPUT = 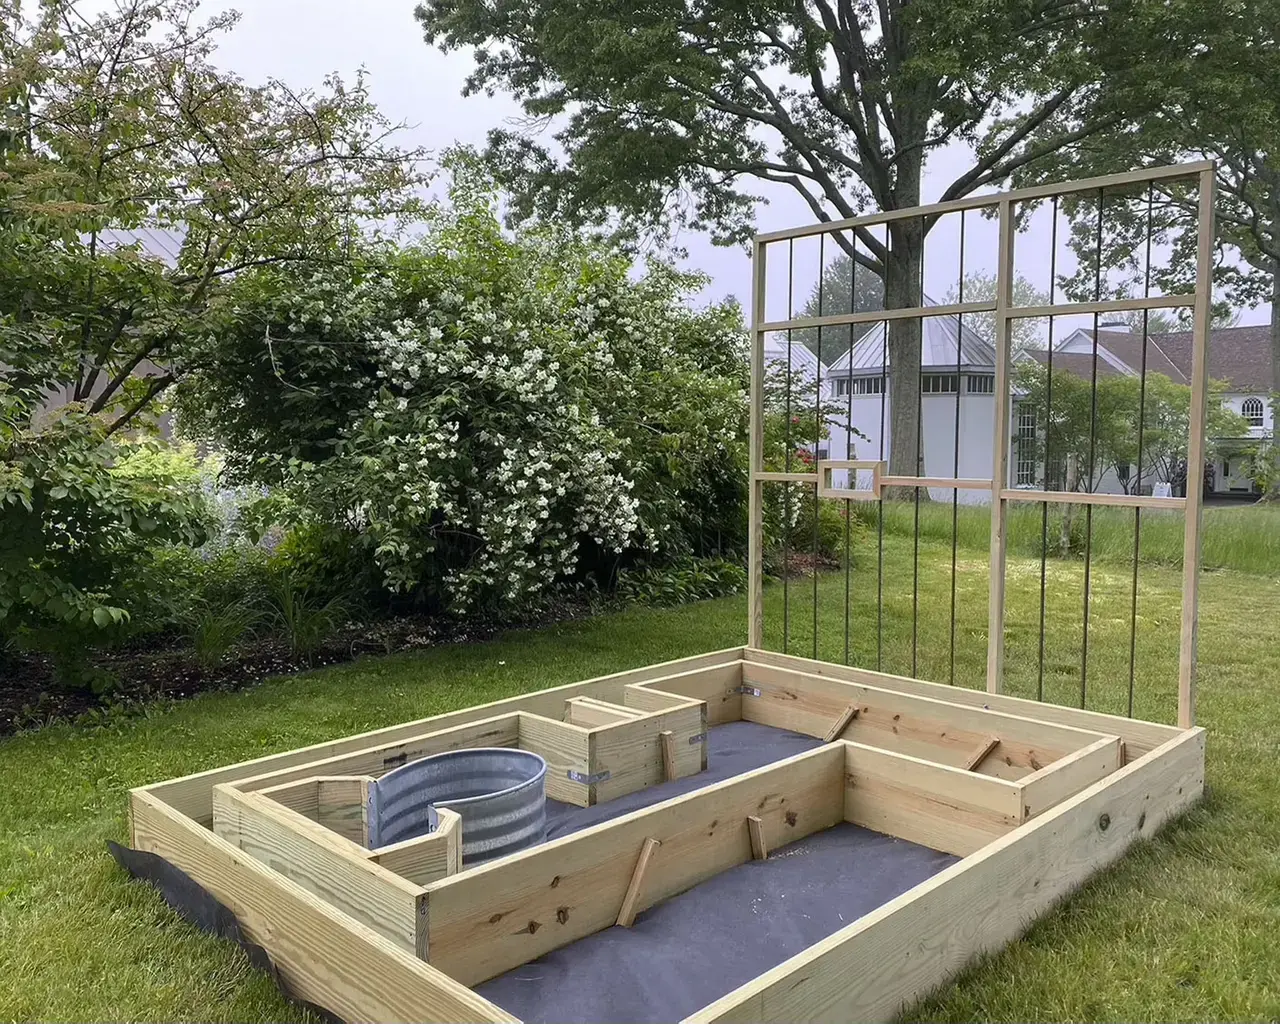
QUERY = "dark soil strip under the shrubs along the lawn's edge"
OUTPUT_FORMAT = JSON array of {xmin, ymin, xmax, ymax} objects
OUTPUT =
[{"xmin": 0, "ymin": 600, "xmax": 599, "ymax": 736}]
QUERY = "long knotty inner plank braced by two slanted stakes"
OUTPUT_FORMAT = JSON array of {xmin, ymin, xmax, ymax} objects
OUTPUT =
[{"xmin": 428, "ymin": 744, "xmax": 845, "ymax": 984}]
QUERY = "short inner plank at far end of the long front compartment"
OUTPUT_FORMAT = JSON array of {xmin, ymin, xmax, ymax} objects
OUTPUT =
[{"xmin": 842, "ymin": 740, "xmax": 1023, "ymax": 856}]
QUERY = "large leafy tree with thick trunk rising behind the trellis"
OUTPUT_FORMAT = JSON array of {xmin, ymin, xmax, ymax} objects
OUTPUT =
[{"xmin": 417, "ymin": 0, "xmax": 1203, "ymax": 474}]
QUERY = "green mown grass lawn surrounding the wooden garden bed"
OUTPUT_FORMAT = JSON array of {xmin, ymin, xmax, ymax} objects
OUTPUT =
[{"xmin": 0, "ymin": 535, "xmax": 1280, "ymax": 1020}]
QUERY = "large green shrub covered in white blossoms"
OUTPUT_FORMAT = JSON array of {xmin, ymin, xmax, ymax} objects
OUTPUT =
[{"xmin": 182, "ymin": 171, "xmax": 746, "ymax": 611}]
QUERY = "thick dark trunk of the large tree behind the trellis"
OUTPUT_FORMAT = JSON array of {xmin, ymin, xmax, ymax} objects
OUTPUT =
[{"xmin": 884, "ymin": 161, "xmax": 929, "ymax": 500}]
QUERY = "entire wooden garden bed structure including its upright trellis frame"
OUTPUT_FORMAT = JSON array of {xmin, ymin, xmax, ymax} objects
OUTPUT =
[{"xmin": 120, "ymin": 163, "xmax": 1213, "ymax": 1021}]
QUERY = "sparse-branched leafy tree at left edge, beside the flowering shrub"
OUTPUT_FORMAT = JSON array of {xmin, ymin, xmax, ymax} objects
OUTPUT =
[{"xmin": 0, "ymin": 0, "xmax": 421, "ymax": 640}]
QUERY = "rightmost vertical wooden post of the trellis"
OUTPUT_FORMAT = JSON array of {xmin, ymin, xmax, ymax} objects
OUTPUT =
[{"xmin": 1178, "ymin": 166, "xmax": 1216, "ymax": 728}]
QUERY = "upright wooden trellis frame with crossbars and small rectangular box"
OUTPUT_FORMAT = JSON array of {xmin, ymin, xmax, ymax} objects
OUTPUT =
[{"xmin": 748, "ymin": 161, "xmax": 1215, "ymax": 728}]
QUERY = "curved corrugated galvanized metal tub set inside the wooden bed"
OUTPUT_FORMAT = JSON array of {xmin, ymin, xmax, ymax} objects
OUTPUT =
[{"xmin": 369, "ymin": 746, "xmax": 547, "ymax": 868}]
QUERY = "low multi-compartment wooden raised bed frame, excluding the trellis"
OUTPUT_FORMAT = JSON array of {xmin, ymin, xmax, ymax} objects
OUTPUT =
[{"xmin": 131, "ymin": 648, "xmax": 1204, "ymax": 1020}]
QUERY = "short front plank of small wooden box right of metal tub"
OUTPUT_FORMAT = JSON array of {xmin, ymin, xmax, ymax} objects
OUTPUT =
[{"xmin": 591, "ymin": 703, "xmax": 707, "ymax": 804}]
